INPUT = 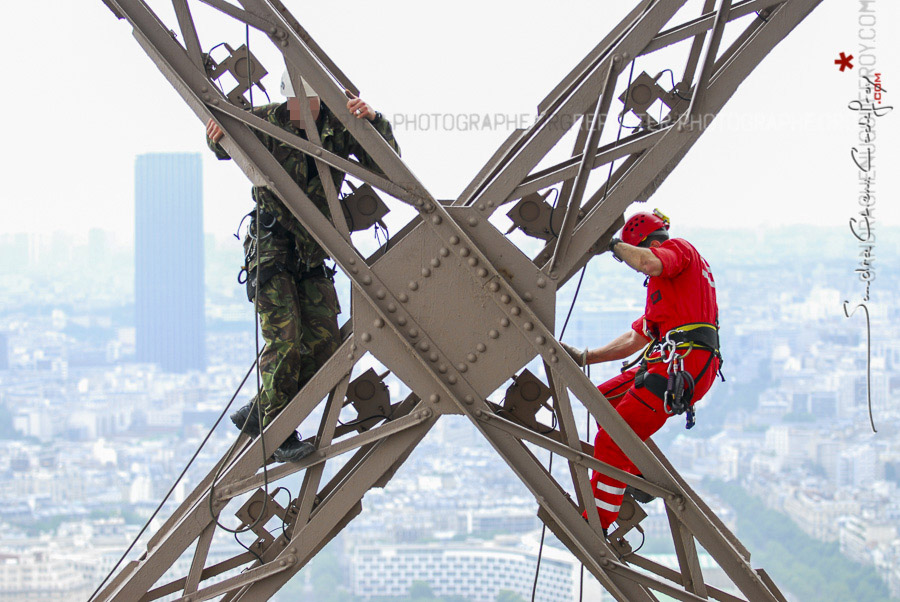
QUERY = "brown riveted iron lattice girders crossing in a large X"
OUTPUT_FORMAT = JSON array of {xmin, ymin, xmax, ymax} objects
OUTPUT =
[{"xmin": 93, "ymin": 0, "xmax": 821, "ymax": 602}]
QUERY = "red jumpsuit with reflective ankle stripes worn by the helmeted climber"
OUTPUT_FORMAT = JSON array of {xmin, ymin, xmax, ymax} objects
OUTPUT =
[{"xmin": 591, "ymin": 238, "xmax": 719, "ymax": 528}]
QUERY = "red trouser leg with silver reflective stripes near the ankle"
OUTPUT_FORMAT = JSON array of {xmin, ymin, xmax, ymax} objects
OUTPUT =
[{"xmin": 591, "ymin": 367, "xmax": 669, "ymax": 529}]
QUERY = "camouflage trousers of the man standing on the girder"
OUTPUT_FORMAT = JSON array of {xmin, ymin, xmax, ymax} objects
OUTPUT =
[{"xmin": 251, "ymin": 272, "xmax": 341, "ymax": 426}]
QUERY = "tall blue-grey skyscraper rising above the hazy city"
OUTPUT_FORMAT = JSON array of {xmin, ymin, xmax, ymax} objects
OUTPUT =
[{"xmin": 134, "ymin": 153, "xmax": 206, "ymax": 372}]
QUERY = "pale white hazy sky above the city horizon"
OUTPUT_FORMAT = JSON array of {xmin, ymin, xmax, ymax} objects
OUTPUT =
[{"xmin": 0, "ymin": 0, "xmax": 900, "ymax": 239}]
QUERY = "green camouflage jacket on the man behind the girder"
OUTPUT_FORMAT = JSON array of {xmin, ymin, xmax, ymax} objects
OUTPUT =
[{"xmin": 206, "ymin": 103, "xmax": 400, "ymax": 269}]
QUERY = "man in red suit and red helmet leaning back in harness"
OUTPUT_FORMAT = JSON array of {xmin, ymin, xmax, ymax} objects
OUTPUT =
[{"xmin": 563, "ymin": 210, "xmax": 721, "ymax": 529}]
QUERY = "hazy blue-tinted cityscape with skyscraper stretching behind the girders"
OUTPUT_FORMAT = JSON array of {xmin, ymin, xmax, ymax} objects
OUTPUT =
[{"xmin": 0, "ymin": 153, "xmax": 900, "ymax": 602}]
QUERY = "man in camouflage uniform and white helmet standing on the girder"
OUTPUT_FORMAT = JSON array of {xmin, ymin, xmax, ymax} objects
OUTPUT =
[{"xmin": 206, "ymin": 75, "xmax": 399, "ymax": 462}]
